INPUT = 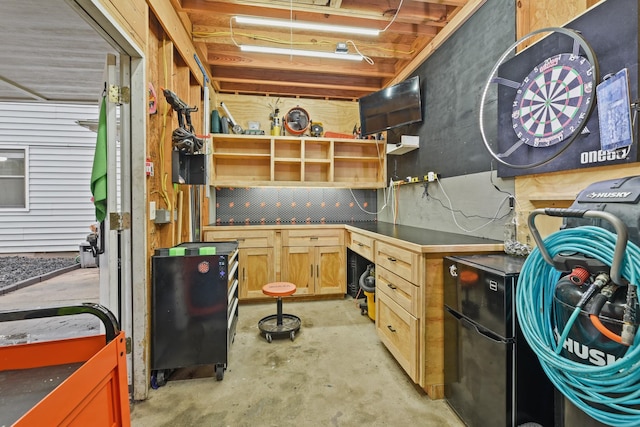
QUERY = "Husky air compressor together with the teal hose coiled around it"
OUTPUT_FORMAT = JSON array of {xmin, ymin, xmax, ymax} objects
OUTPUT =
[{"xmin": 516, "ymin": 176, "xmax": 640, "ymax": 426}]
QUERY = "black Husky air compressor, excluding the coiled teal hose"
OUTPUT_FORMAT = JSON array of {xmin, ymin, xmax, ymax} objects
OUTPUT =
[{"xmin": 554, "ymin": 176, "xmax": 640, "ymax": 366}]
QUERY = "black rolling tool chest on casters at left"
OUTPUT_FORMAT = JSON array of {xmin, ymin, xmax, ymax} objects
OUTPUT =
[{"xmin": 151, "ymin": 242, "xmax": 238, "ymax": 385}]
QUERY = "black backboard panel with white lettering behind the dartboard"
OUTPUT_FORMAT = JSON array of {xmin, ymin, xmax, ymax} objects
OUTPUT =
[{"xmin": 498, "ymin": 0, "xmax": 639, "ymax": 177}]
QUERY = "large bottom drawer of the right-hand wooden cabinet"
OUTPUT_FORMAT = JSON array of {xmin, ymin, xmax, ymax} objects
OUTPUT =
[{"xmin": 376, "ymin": 292, "xmax": 419, "ymax": 383}]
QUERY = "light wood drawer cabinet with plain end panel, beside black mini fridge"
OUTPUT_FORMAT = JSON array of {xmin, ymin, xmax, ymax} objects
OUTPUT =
[{"xmin": 346, "ymin": 226, "xmax": 503, "ymax": 399}]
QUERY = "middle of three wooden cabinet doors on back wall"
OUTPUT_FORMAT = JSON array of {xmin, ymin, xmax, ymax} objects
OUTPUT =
[{"xmin": 281, "ymin": 246, "xmax": 316, "ymax": 295}]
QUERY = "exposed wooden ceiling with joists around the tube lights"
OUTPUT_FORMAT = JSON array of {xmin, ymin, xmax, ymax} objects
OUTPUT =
[{"xmin": 172, "ymin": 0, "xmax": 484, "ymax": 100}]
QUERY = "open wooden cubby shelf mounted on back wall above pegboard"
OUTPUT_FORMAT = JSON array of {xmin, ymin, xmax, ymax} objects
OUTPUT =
[{"xmin": 210, "ymin": 134, "xmax": 386, "ymax": 188}]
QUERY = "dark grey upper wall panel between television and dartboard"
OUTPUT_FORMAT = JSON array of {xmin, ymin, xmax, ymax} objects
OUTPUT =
[{"xmin": 387, "ymin": 0, "xmax": 516, "ymax": 179}]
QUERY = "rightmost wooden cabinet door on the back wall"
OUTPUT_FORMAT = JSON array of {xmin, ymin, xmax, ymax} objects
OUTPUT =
[{"xmin": 315, "ymin": 246, "xmax": 347, "ymax": 295}]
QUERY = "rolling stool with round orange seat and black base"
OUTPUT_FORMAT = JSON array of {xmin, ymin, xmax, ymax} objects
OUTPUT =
[{"xmin": 258, "ymin": 282, "xmax": 301, "ymax": 342}]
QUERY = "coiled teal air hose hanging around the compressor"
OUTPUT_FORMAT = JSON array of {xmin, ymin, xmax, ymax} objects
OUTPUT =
[{"xmin": 516, "ymin": 226, "xmax": 640, "ymax": 427}]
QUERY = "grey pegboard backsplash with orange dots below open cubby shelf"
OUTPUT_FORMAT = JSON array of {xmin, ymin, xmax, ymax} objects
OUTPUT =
[{"xmin": 216, "ymin": 188, "xmax": 377, "ymax": 225}]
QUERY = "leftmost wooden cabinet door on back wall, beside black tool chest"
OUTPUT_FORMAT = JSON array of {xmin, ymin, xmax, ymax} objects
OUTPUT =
[{"xmin": 238, "ymin": 248, "xmax": 275, "ymax": 299}]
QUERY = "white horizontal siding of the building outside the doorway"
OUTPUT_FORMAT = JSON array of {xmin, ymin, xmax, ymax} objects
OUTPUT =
[{"xmin": 0, "ymin": 102, "xmax": 98, "ymax": 253}]
